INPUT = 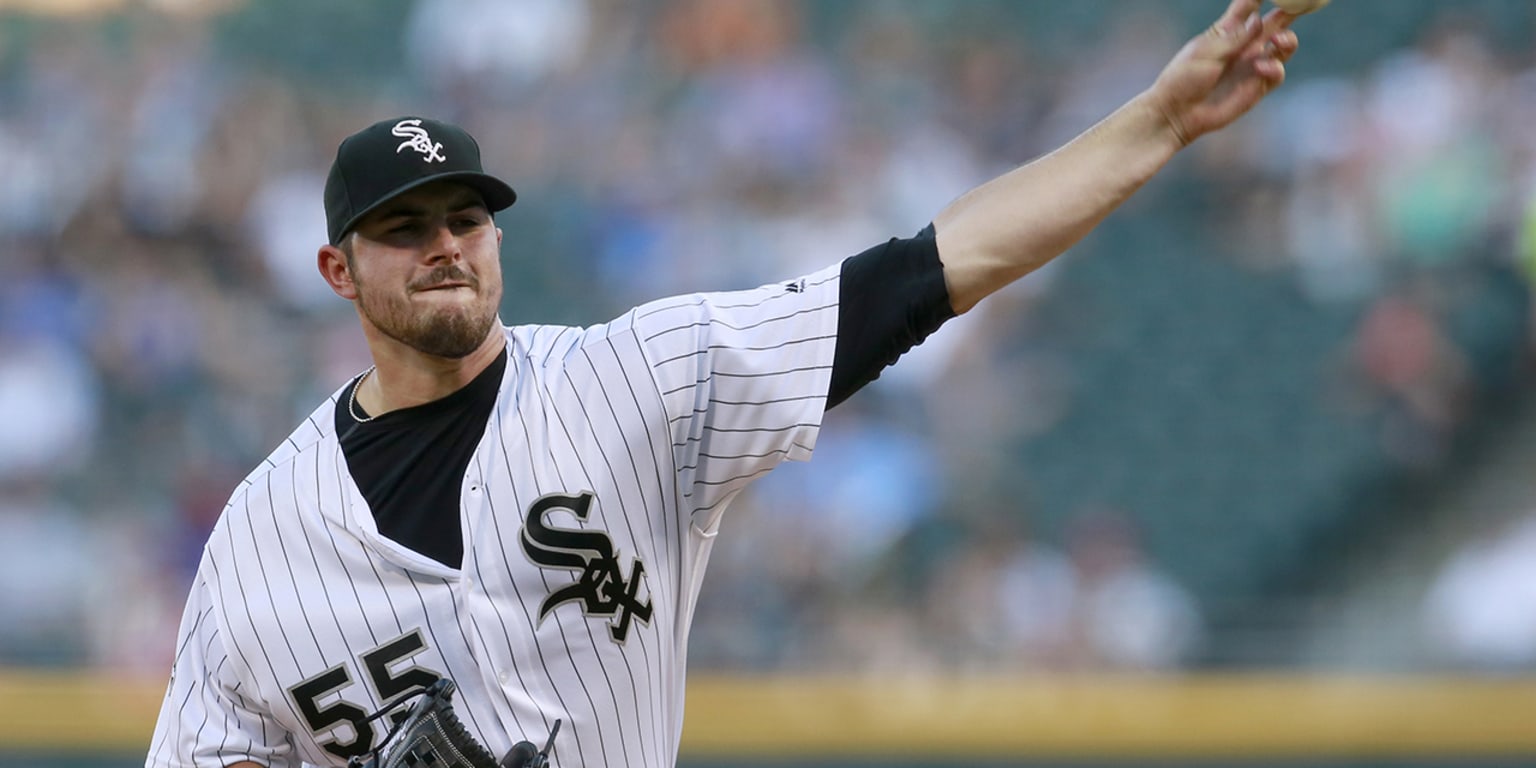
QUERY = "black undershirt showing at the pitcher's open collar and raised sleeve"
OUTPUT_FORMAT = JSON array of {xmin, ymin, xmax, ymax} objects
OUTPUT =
[{"xmin": 336, "ymin": 226, "xmax": 954, "ymax": 568}]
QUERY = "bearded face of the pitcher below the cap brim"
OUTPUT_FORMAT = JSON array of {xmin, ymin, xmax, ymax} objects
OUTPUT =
[{"xmin": 349, "ymin": 183, "xmax": 501, "ymax": 358}]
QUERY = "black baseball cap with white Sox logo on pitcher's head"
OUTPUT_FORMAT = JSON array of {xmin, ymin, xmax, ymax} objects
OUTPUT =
[{"xmin": 326, "ymin": 117, "xmax": 518, "ymax": 246}]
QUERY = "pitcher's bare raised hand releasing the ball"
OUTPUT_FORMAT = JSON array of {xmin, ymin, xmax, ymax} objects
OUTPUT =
[{"xmin": 1146, "ymin": 0, "xmax": 1298, "ymax": 144}]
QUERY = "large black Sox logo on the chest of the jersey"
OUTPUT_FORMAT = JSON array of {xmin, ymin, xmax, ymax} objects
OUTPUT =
[{"xmin": 522, "ymin": 493, "xmax": 651, "ymax": 642}]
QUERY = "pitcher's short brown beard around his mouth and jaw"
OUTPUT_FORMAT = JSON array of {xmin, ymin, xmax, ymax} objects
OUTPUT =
[{"xmin": 358, "ymin": 266, "xmax": 498, "ymax": 359}]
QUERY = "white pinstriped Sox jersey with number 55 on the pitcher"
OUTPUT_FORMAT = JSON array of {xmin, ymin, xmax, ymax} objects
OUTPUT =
[{"xmin": 146, "ymin": 266, "xmax": 839, "ymax": 768}]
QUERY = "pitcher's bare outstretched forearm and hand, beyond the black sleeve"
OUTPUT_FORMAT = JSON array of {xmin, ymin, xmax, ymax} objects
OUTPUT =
[{"xmin": 934, "ymin": 0, "xmax": 1296, "ymax": 313}]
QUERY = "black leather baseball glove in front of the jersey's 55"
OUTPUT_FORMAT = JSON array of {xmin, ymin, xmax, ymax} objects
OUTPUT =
[{"xmin": 347, "ymin": 677, "xmax": 561, "ymax": 768}]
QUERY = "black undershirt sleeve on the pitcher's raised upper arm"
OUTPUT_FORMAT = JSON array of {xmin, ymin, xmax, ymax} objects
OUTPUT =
[{"xmin": 826, "ymin": 224, "xmax": 955, "ymax": 409}]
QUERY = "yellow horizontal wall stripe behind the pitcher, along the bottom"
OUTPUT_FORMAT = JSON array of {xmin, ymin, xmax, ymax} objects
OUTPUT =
[{"xmin": 9, "ymin": 671, "xmax": 1536, "ymax": 759}]
